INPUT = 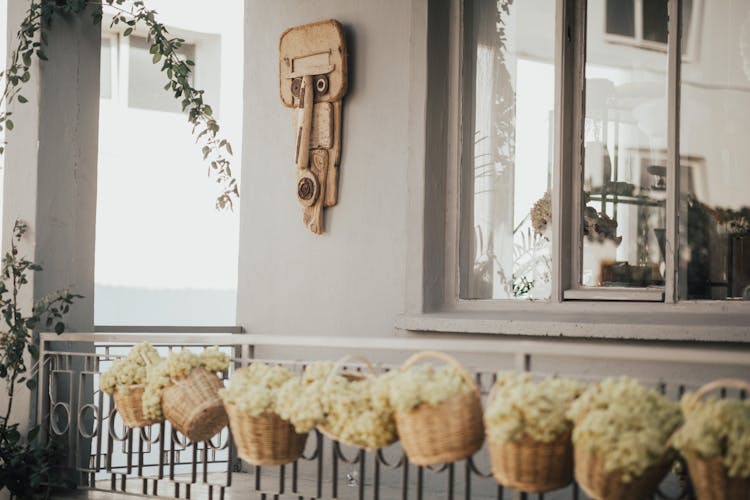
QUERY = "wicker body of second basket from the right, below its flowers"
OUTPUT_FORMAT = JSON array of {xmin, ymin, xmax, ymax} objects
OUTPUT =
[{"xmin": 574, "ymin": 447, "xmax": 675, "ymax": 500}]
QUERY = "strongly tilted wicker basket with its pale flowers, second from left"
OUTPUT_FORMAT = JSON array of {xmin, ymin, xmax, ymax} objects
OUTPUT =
[{"xmin": 143, "ymin": 347, "xmax": 229, "ymax": 441}]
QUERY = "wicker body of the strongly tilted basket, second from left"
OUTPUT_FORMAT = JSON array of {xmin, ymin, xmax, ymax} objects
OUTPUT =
[{"xmin": 161, "ymin": 367, "xmax": 227, "ymax": 441}]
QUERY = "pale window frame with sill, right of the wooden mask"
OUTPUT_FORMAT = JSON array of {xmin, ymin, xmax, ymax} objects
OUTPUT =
[{"xmin": 402, "ymin": 0, "xmax": 750, "ymax": 342}]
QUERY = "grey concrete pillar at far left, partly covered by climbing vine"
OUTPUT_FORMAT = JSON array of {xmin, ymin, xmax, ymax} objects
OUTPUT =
[{"xmin": 2, "ymin": 0, "xmax": 101, "ymax": 458}]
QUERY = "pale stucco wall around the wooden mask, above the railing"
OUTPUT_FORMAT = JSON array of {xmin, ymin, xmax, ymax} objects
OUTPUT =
[{"xmin": 237, "ymin": 0, "xmax": 412, "ymax": 336}]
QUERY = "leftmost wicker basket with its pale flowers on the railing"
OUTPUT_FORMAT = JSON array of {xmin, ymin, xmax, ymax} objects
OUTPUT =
[{"xmin": 99, "ymin": 342, "xmax": 163, "ymax": 429}]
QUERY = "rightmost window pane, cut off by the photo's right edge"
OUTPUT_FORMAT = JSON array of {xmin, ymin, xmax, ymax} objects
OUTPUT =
[{"xmin": 679, "ymin": 0, "xmax": 750, "ymax": 300}]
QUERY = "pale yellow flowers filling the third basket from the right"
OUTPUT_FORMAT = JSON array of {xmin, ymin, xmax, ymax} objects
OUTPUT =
[{"xmin": 484, "ymin": 372, "xmax": 585, "ymax": 443}]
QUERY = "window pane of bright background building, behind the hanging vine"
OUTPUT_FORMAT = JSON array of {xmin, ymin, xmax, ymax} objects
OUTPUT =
[{"xmin": 128, "ymin": 36, "xmax": 192, "ymax": 113}]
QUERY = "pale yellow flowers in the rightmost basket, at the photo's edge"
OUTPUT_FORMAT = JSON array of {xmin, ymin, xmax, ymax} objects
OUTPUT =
[{"xmin": 673, "ymin": 393, "xmax": 750, "ymax": 478}]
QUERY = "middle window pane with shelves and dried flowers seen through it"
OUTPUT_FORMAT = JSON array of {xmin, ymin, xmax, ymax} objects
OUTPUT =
[{"xmin": 578, "ymin": 2, "xmax": 667, "ymax": 287}]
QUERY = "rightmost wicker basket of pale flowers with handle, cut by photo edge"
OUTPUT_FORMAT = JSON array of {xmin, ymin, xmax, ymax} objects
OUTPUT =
[{"xmin": 672, "ymin": 379, "xmax": 750, "ymax": 500}]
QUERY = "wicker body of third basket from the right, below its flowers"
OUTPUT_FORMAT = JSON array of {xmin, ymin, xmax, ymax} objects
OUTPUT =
[{"xmin": 487, "ymin": 431, "xmax": 573, "ymax": 493}]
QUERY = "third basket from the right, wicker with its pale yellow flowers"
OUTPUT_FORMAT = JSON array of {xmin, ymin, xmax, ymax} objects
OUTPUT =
[{"xmin": 484, "ymin": 372, "xmax": 585, "ymax": 493}]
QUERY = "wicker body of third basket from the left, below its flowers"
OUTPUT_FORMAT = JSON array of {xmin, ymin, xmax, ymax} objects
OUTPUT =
[{"xmin": 224, "ymin": 404, "xmax": 307, "ymax": 465}]
